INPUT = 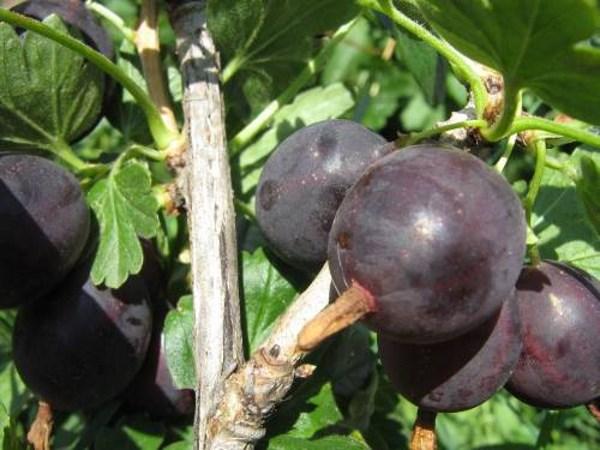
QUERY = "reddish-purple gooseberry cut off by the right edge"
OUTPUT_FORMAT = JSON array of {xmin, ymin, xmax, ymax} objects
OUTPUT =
[{"xmin": 506, "ymin": 261, "xmax": 600, "ymax": 408}]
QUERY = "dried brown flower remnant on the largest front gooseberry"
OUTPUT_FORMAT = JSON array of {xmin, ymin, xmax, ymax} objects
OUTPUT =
[{"xmin": 297, "ymin": 282, "xmax": 375, "ymax": 352}]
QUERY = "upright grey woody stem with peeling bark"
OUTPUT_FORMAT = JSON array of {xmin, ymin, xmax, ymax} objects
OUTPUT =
[{"xmin": 171, "ymin": 1, "xmax": 243, "ymax": 450}]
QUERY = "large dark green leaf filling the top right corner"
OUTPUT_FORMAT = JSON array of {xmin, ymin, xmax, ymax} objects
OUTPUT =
[{"xmin": 416, "ymin": 0, "xmax": 600, "ymax": 124}]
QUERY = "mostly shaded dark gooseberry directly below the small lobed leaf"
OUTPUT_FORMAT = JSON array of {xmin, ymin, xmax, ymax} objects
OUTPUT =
[{"xmin": 13, "ymin": 267, "xmax": 152, "ymax": 411}]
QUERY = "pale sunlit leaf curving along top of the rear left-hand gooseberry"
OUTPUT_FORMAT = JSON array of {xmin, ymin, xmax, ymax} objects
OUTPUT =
[{"xmin": 240, "ymin": 83, "xmax": 354, "ymax": 192}]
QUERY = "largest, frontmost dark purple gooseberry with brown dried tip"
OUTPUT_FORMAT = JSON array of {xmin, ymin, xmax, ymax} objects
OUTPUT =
[{"xmin": 328, "ymin": 145, "xmax": 526, "ymax": 344}]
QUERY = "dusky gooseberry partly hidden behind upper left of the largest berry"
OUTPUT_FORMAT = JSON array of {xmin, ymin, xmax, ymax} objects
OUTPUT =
[{"xmin": 256, "ymin": 120, "xmax": 386, "ymax": 272}]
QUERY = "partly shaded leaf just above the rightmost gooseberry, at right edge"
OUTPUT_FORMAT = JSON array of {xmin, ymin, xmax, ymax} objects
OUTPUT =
[{"xmin": 532, "ymin": 150, "xmax": 600, "ymax": 278}]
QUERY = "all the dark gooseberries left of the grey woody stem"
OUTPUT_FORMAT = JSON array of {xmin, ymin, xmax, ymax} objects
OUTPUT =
[{"xmin": 0, "ymin": 0, "xmax": 194, "ymax": 417}]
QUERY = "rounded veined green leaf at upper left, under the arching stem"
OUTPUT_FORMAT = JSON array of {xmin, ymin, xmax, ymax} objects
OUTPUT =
[{"xmin": 0, "ymin": 15, "xmax": 104, "ymax": 151}]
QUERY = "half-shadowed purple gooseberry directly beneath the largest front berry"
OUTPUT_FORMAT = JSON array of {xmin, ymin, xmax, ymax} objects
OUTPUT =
[{"xmin": 379, "ymin": 295, "xmax": 522, "ymax": 412}]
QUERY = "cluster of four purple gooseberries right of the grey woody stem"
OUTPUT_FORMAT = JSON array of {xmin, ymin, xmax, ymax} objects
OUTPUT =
[{"xmin": 256, "ymin": 120, "xmax": 600, "ymax": 412}]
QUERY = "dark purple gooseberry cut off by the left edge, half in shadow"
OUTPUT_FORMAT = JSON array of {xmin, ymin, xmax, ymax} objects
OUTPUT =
[{"xmin": 0, "ymin": 154, "xmax": 90, "ymax": 308}]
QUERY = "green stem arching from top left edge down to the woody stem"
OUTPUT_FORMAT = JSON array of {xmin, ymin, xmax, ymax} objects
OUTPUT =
[{"xmin": 0, "ymin": 8, "xmax": 179, "ymax": 149}]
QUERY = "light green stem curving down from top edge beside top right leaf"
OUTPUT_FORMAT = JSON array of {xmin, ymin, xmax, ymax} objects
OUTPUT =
[{"xmin": 359, "ymin": 0, "xmax": 487, "ymax": 117}]
